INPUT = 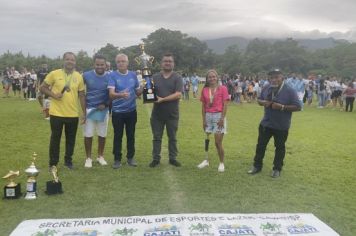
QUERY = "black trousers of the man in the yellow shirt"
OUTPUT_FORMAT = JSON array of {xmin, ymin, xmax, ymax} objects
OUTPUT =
[{"xmin": 49, "ymin": 116, "xmax": 78, "ymax": 166}]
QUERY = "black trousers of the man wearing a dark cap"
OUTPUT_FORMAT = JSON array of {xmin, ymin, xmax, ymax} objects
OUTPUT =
[{"xmin": 254, "ymin": 125, "xmax": 288, "ymax": 171}]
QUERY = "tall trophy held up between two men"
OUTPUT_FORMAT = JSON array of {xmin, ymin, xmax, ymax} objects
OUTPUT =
[{"xmin": 135, "ymin": 44, "xmax": 157, "ymax": 103}]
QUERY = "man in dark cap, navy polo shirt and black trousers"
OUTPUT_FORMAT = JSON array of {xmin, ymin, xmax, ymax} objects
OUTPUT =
[{"xmin": 248, "ymin": 69, "xmax": 301, "ymax": 178}]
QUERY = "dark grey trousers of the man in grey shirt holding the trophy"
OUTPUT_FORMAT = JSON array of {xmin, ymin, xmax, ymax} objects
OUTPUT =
[{"xmin": 151, "ymin": 115, "xmax": 179, "ymax": 161}]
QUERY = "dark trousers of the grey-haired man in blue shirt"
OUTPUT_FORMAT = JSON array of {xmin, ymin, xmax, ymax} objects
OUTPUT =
[{"xmin": 112, "ymin": 110, "xmax": 137, "ymax": 161}]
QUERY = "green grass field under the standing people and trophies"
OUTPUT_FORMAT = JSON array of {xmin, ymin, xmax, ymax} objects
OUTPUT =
[{"xmin": 0, "ymin": 89, "xmax": 356, "ymax": 236}]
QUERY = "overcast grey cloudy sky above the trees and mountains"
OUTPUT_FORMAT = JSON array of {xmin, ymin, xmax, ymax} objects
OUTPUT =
[{"xmin": 0, "ymin": 0, "xmax": 356, "ymax": 57}]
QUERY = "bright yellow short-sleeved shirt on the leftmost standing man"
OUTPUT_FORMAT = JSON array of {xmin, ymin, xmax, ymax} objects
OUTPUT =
[{"xmin": 44, "ymin": 69, "xmax": 84, "ymax": 117}]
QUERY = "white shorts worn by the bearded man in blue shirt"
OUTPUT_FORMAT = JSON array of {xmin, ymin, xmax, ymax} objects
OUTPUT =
[{"xmin": 83, "ymin": 109, "xmax": 109, "ymax": 138}]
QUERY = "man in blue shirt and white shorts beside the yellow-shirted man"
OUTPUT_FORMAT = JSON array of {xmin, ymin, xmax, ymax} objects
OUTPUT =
[{"xmin": 83, "ymin": 55, "xmax": 109, "ymax": 168}]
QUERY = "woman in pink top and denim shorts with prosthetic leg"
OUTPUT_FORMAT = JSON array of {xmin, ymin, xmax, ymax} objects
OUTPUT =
[{"xmin": 198, "ymin": 70, "xmax": 229, "ymax": 172}]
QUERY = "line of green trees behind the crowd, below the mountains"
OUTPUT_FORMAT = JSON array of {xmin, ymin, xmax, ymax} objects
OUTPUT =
[{"xmin": 0, "ymin": 28, "xmax": 356, "ymax": 78}]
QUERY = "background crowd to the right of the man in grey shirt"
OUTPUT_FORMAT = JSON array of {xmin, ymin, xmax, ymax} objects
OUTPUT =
[{"xmin": 182, "ymin": 73, "xmax": 356, "ymax": 112}]
